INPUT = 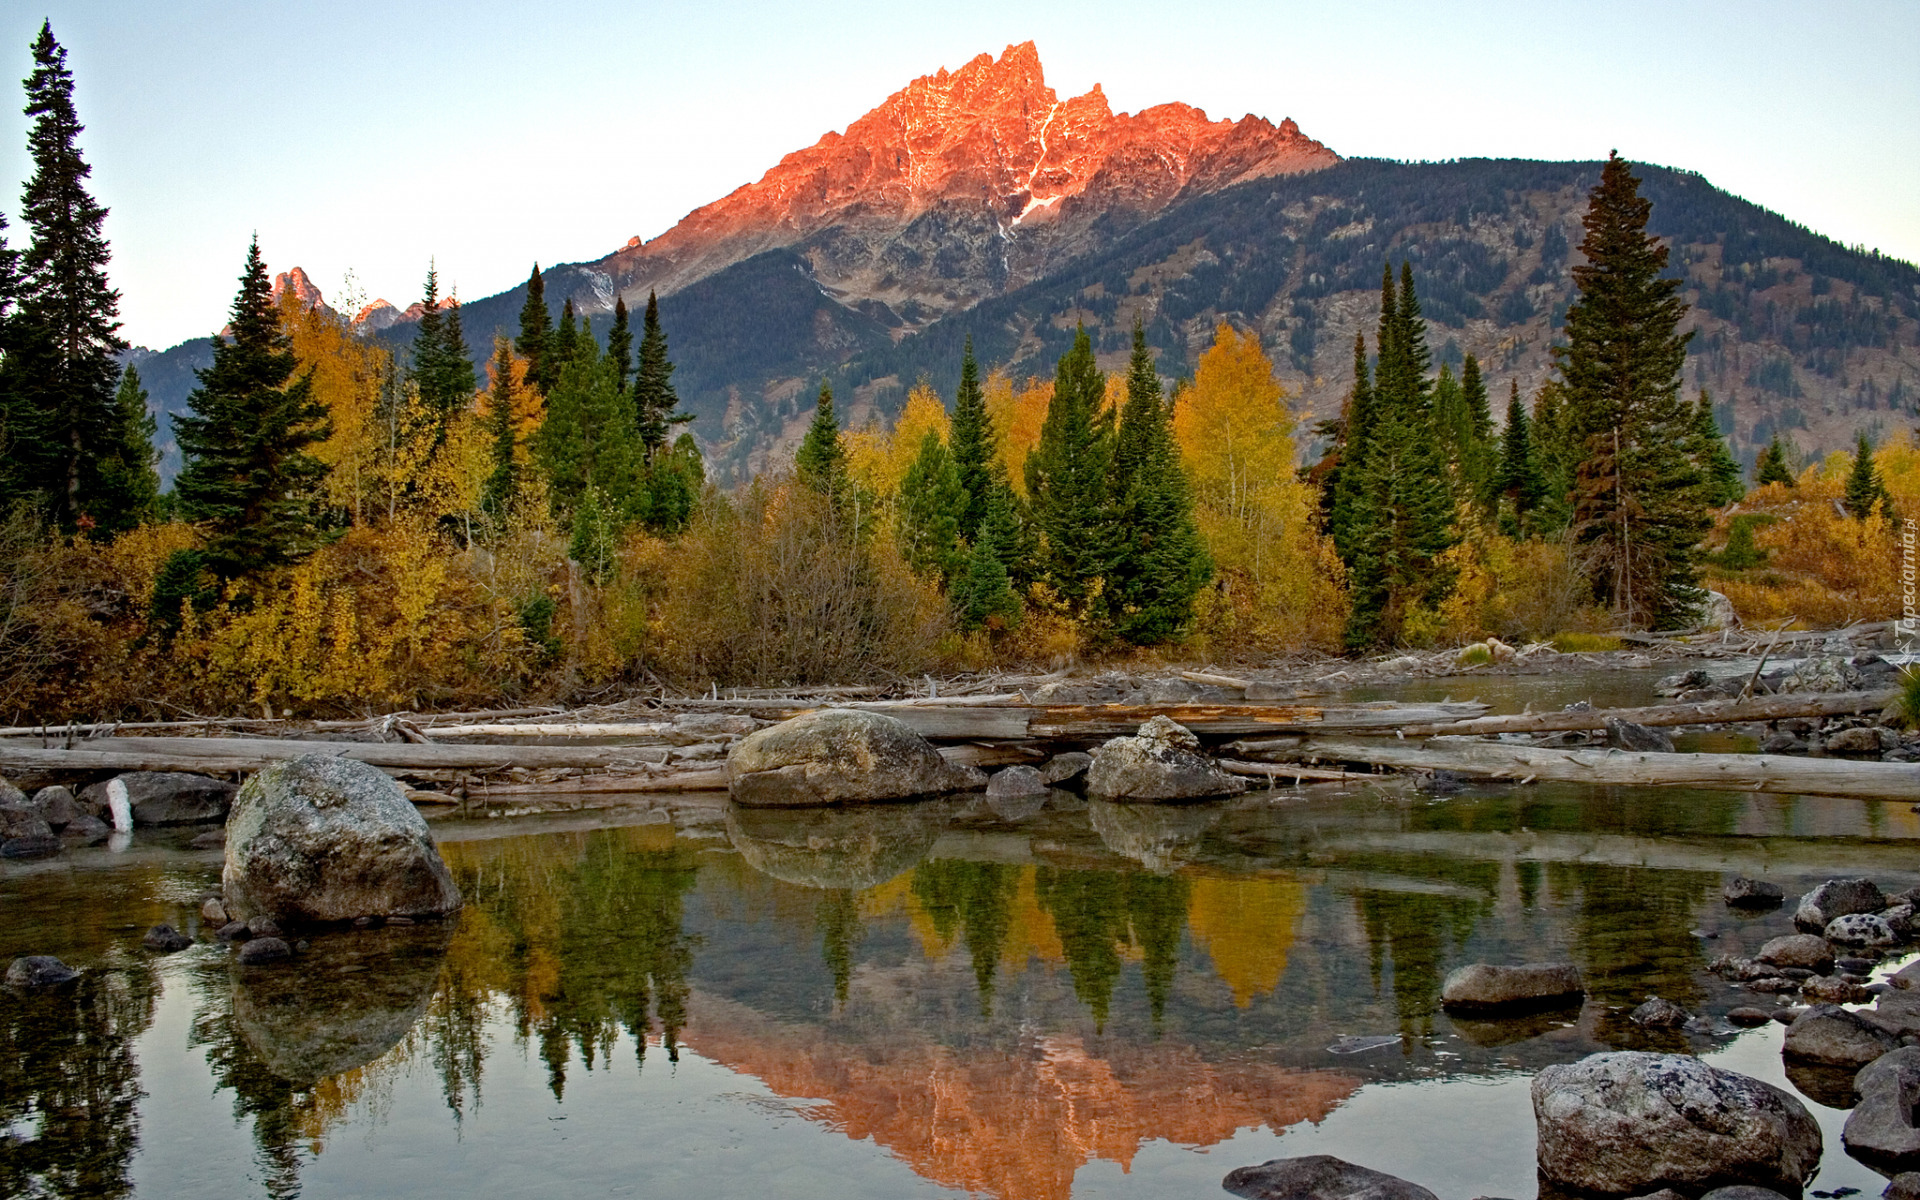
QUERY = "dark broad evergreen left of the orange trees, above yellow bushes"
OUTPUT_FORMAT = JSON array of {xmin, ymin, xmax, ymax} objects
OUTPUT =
[{"xmin": 173, "ymin": 238, "xmax": 332, "ymax": 580}]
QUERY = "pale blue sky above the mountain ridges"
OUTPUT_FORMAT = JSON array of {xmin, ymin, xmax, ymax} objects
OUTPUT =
[{"xmin": 0, "ymin": 0, "xmax": 1920, "ymax": 348}]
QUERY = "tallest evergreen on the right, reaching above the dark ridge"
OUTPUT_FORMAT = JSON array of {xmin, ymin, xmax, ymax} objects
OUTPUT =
[{"xmin": 1553, "ymin": 152, "xmax": 1711, "ymax": 628}]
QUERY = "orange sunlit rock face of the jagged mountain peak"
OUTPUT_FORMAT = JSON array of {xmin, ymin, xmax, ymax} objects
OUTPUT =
[{"xmin": 599, "ymin": 42, "xmax": 1340, "ymax": 309}]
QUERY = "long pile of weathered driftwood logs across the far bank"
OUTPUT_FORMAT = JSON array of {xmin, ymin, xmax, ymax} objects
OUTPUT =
[{"xmin": 0, "ymin": 672, "xmax": 1920, "ymax": 801}]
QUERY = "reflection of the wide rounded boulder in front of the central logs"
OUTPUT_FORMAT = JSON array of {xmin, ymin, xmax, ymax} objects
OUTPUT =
[{"xmin": 726, "ymin": 803, "xmax": 948, "ymax": 891}]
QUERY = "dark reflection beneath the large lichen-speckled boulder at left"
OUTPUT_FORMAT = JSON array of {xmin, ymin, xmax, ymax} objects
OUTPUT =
[{"xmin": 234, "ymin": 924, "xmax": 451, "ymax": 1087}]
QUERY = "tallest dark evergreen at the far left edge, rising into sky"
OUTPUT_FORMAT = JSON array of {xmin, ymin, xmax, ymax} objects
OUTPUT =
[{"xmin": 0, "ymin": 23, "xmax": 132, "ymax": 530}]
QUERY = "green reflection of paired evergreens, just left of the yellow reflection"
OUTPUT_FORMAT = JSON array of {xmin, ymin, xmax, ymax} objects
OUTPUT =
[{"xmin": 1035, "ymin": 866, "xmax": 1188, "ymax": 1029}]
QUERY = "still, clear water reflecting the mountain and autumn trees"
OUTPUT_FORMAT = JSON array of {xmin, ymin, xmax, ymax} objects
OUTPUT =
[{"xmin": 0, "ymin": 768, "xmax": 1920, "ymax": 1200}]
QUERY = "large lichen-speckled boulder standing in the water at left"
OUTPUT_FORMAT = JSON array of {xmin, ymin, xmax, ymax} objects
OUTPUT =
[{"xmin": 221, "ymin": 755, "xmax": 461, "ymax": 924}]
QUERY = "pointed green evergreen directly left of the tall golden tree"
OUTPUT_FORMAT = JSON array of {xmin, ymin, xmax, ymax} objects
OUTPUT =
[{"xmin": 1104, "ymin": 321, "xmax": 1213, "ymax": 645}]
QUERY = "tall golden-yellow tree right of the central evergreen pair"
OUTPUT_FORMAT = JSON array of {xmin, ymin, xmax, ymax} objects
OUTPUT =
[{"xmin": 1173, "ymin": 323, "xmax": 1346, "ymax": 651}]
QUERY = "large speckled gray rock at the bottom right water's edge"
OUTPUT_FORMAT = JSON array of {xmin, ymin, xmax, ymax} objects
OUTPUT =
[{"xmin": 1532, "ymin": 1052, "xmax": 1822, "ymax": 1196}]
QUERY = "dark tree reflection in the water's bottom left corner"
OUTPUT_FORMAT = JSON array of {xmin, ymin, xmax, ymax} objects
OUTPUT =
[{"xmin": 0, "ymin": 962, "xmax": 156, "ymax": 1196}]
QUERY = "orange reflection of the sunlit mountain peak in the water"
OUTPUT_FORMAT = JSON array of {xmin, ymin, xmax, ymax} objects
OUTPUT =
[{"xmin": 684, "ymin": 991, "xmax": 1361, "ymax": 1200}]
